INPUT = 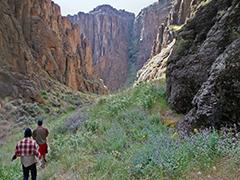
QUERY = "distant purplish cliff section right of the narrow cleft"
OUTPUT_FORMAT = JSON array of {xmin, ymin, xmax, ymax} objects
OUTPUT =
[{"xmin": 130, "ymin": 0, "xmax": 172, "ymax": 69}]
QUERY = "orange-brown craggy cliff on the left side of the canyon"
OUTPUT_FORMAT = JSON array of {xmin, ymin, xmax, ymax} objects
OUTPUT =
[{"xmin": 0, "ymin": 0, "xmax": 107, "ymax": 100}]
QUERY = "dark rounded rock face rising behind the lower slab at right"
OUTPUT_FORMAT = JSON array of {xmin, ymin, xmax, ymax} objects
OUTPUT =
[{"xmin": 167, "ymin": 0, "xmax": 240, "ymax": 113}]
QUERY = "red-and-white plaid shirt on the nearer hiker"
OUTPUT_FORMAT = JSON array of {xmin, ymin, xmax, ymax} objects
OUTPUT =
[{"xmin": 15, "ymin": 138, "xmax": 40, "ymax": 157}]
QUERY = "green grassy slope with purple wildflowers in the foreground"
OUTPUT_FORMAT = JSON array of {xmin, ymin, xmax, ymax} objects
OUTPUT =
[{"xmin": 0, "ymin": 84, "xmax": 240, "ymax": 179}]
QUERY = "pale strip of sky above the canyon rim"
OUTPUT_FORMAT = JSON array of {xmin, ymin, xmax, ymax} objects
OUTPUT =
[{"xmin": 53, "ymin": 0, "xmax": 157, "ymax": 16}]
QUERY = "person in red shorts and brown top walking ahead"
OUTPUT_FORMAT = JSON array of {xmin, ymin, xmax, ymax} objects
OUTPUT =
[{"xmin": 33, "ymin": 120, "xmax": 49, "ymax": 163}]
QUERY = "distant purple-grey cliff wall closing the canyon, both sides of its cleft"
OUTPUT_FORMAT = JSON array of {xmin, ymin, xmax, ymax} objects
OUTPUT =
[{"xmin": 68, "ymin": 0, "xmax": 171, "ymax": 90}]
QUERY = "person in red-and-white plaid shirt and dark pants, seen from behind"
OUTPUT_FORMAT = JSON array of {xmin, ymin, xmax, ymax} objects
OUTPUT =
[{"xmin": 12, "ymin": 128, "xmax": 40, "ymax": 180}]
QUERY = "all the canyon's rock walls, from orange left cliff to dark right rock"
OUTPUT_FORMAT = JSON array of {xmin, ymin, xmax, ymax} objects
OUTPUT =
[{"xmin": 0, "ymin": 0, "xmax": 240, "ymax": 129}]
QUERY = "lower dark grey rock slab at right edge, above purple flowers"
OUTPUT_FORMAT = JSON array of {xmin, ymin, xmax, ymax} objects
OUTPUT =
[{"xmin": 179, "ymin": 38, "xmax": 240, "ymax": 130}]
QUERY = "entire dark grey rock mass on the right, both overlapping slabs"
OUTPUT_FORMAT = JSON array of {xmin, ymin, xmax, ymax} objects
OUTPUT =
[{"xmin": 167, "ymin": 0, "xmax": 240, "ymax": 129}]
